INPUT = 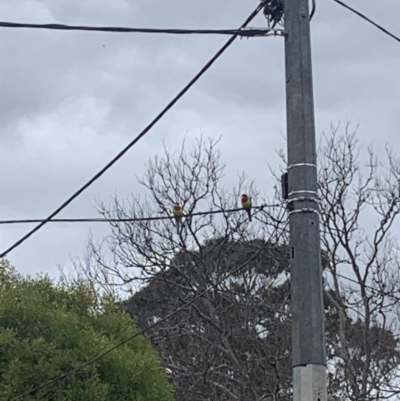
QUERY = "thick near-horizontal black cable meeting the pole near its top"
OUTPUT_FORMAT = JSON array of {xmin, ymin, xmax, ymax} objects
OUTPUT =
[{"xmin": 0, "ymin": 21, "xmax": 276, "ymax": 37}]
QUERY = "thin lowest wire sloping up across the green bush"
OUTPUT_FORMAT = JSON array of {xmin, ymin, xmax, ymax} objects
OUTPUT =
[{"xmin": 11, "ymin": 231, "xmax": 276, "ymax": 401}]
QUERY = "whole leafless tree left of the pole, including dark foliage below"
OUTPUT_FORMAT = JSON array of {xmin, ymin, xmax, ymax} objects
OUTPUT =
[{"xmin": 77, "ymin": 139, "xmax": 290, "ymax": 400}]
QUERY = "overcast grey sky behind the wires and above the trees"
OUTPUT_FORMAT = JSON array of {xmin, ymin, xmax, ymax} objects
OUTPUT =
[{"xmin": 0, "ymin": 0, "xmax": 400, "ymax": 275}]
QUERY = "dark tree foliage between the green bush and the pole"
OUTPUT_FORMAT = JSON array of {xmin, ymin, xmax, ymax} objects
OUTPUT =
[{"xmin": 125, "ymin": 240, "xmax": 291, "ymax": 400}]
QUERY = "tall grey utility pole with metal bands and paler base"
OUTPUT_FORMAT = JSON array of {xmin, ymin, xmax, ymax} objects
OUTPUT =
[{"xmin": 284, "ymin": 0, "xmax": 327, "ymax": 401}]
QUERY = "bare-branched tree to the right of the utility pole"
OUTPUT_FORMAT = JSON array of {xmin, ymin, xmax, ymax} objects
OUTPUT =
[{"xmin": 319, "ymin": 125, "xmax": 400, "ymax": 401}]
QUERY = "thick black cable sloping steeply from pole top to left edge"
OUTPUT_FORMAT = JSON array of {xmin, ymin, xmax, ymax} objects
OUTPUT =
[{"xmin": 0, "ymin": 1, "xmax": 265, "ymax": 258}]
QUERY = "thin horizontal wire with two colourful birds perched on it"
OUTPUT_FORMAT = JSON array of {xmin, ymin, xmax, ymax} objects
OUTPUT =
[{"xmin": 0, "ymin": 204, "xmax": 281, "ymax": 225}]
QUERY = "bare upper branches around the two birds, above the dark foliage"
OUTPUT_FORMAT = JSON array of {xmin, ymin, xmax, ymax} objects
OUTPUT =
[{"xmin": 80, "ymin": 138, "xmax": 287, "ymax": 293}]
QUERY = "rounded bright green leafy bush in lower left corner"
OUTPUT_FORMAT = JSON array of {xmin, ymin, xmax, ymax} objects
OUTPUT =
[{"xmin": 0, "ymin": 262, "xmax": 172, "ymax": 401}]
